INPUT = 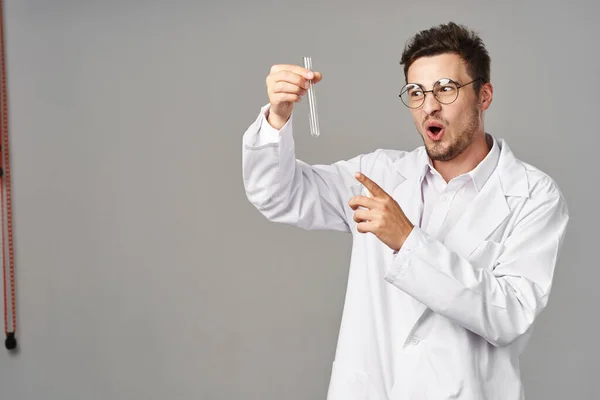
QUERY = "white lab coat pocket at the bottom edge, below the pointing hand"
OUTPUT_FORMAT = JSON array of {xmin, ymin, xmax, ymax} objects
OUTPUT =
[{"xmin": 327, "ymin": 361, "xmax": 370, "ymax": 400}]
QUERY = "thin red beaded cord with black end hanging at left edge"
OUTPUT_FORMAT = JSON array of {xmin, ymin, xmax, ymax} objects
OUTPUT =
[{"xmin": 0, "ymin": 0, "xmax": 17, "ymax": 350}]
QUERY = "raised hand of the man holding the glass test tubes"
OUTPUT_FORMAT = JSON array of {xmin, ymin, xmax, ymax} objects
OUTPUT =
[{"xmin": 267, "ymin": 64, "xmax": 322, "ymax": 129}]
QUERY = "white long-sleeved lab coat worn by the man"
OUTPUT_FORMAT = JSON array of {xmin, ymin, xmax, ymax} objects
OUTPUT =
[{"xmin": 242, "ymin": 105, "xmax": 569, "ymax": 400}]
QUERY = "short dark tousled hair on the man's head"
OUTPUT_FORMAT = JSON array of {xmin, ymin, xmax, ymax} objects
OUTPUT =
[{"xmin": 400, "ymin": 22, "xmax": 490, "ymax": 93}]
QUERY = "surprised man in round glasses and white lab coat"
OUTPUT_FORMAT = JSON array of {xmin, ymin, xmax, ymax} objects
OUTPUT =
[{"xmin": 243, "ymin": 23, "xmax": 569, "ymax": 400}]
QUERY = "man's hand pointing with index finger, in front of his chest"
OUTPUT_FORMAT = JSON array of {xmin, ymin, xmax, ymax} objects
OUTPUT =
[{"xmin": 348, "ymin": 172, "xmax": 414, "ymax": 251}]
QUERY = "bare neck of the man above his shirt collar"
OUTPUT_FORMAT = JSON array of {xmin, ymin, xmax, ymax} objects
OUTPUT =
[{"xmin": 433, "ymin": 133, "xmax": 492, "ymax": 182}]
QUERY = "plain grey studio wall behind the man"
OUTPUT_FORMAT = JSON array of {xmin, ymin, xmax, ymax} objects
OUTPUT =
[{"xmin": 0, "ymin": 0, "xmax": 600, "ymax": 400}]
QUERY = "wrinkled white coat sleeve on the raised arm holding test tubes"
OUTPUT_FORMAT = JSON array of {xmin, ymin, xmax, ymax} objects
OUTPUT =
[{"xmin": 242, "ymin": 104, "xmax": 367, "ymax": 232}]
